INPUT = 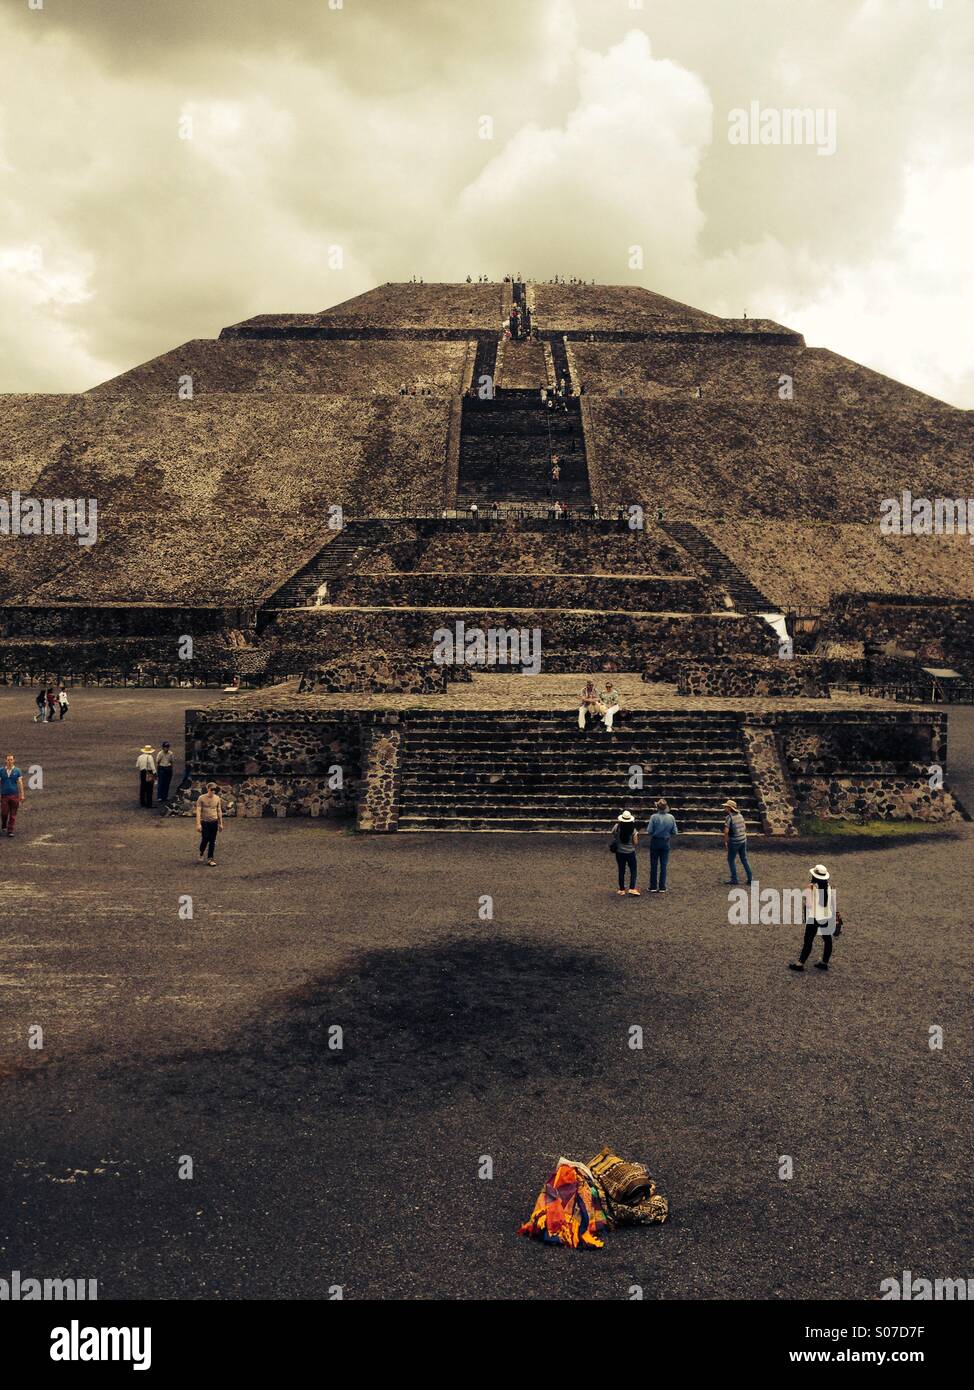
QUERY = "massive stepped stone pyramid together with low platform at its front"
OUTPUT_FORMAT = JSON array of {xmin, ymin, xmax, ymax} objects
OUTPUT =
[{"xmin": 0, "ymin": 281, "xmax": 974, "ymax": 834}]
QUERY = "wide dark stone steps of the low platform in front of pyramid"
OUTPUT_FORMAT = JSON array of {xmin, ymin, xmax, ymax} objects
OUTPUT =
[{"xmin": 399, "ymin": 711, "xmax": 761, "ymax": 837}]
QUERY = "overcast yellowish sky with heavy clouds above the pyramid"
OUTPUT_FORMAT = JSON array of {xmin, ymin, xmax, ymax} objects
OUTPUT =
[{"xmin": 0, "ymin": 0, "xmax": 974, "ymax": 407}]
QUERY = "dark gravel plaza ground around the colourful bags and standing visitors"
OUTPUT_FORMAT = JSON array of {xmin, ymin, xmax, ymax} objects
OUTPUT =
[{"xmin": 0, "ymin": 689, "xmax": 974, "ymax": 1300}]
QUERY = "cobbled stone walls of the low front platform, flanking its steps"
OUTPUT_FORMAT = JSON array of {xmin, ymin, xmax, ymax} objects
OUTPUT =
[{"xmin": 186, "ymin": 691, "xmax": 963, "ymax": 835}]
